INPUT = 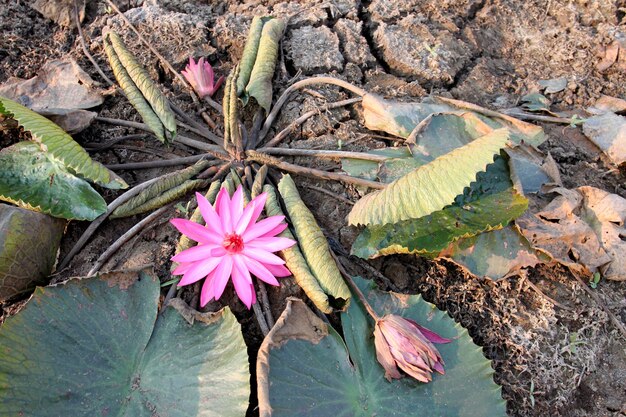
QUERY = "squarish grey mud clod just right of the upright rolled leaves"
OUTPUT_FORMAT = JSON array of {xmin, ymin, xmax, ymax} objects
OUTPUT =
[{"xmin": 286, "ymin": 26, "xmax": 344, "ymax": 75}]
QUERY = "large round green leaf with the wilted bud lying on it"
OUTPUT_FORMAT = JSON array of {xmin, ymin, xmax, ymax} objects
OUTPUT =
[{"xmin": 257, "ymin": 279, "xmax": 506, "ymax": 417}]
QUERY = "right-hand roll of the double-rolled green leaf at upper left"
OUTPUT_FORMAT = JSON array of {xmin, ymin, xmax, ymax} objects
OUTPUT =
[{"xmin": 107, "ymin": 32, "xmax": 176, "ymax": 137}]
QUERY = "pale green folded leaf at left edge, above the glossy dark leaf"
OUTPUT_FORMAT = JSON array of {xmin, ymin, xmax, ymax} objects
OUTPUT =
[{"xmin": 0, "ymin": 97, "xmax": 128, "ymax": 189}]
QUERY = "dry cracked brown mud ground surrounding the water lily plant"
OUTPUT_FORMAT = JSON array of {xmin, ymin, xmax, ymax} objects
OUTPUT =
[{"xmin": 0, "ymin": 0, "xmax": 626, "ymax": 417}]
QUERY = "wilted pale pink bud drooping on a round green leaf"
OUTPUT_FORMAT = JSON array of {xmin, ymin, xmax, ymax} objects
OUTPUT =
[{"xmin": 374, "ymin": 314, "xmax": 451, "ymax": 382}]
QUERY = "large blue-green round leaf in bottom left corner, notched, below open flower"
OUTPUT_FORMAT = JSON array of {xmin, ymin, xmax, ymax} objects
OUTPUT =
[{"xmin": 0, "ymin": 273, "xmax": 250, "ymax": 417}]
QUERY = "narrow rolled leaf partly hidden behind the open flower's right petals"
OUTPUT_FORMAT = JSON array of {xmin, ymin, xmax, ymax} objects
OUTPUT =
[{"xmin": 263, "ymin": 184, "xmax": 333, "ymax": 314}]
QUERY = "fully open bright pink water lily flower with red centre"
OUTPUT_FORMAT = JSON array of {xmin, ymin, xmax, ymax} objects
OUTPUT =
[{"xmin": 170, "ymin": 186, "xmax": 296, "ymax": 308}]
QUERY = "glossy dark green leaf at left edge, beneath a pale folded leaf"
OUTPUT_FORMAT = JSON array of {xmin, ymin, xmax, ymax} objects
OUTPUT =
[{"xmin": 0, "ymin": 142, "xmax": 107, "ymax": 220}]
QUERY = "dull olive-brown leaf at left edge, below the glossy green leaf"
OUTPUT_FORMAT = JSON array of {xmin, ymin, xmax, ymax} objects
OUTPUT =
[{"xmin": 0, "ymin": 204, "xmax": 67, "ymax": 301}]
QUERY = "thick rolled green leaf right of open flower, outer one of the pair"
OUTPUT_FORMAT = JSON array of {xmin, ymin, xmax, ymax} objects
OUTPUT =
[{"xmin": 278, "ymin": 175, "xmax": 351, "ymax": 309}]
